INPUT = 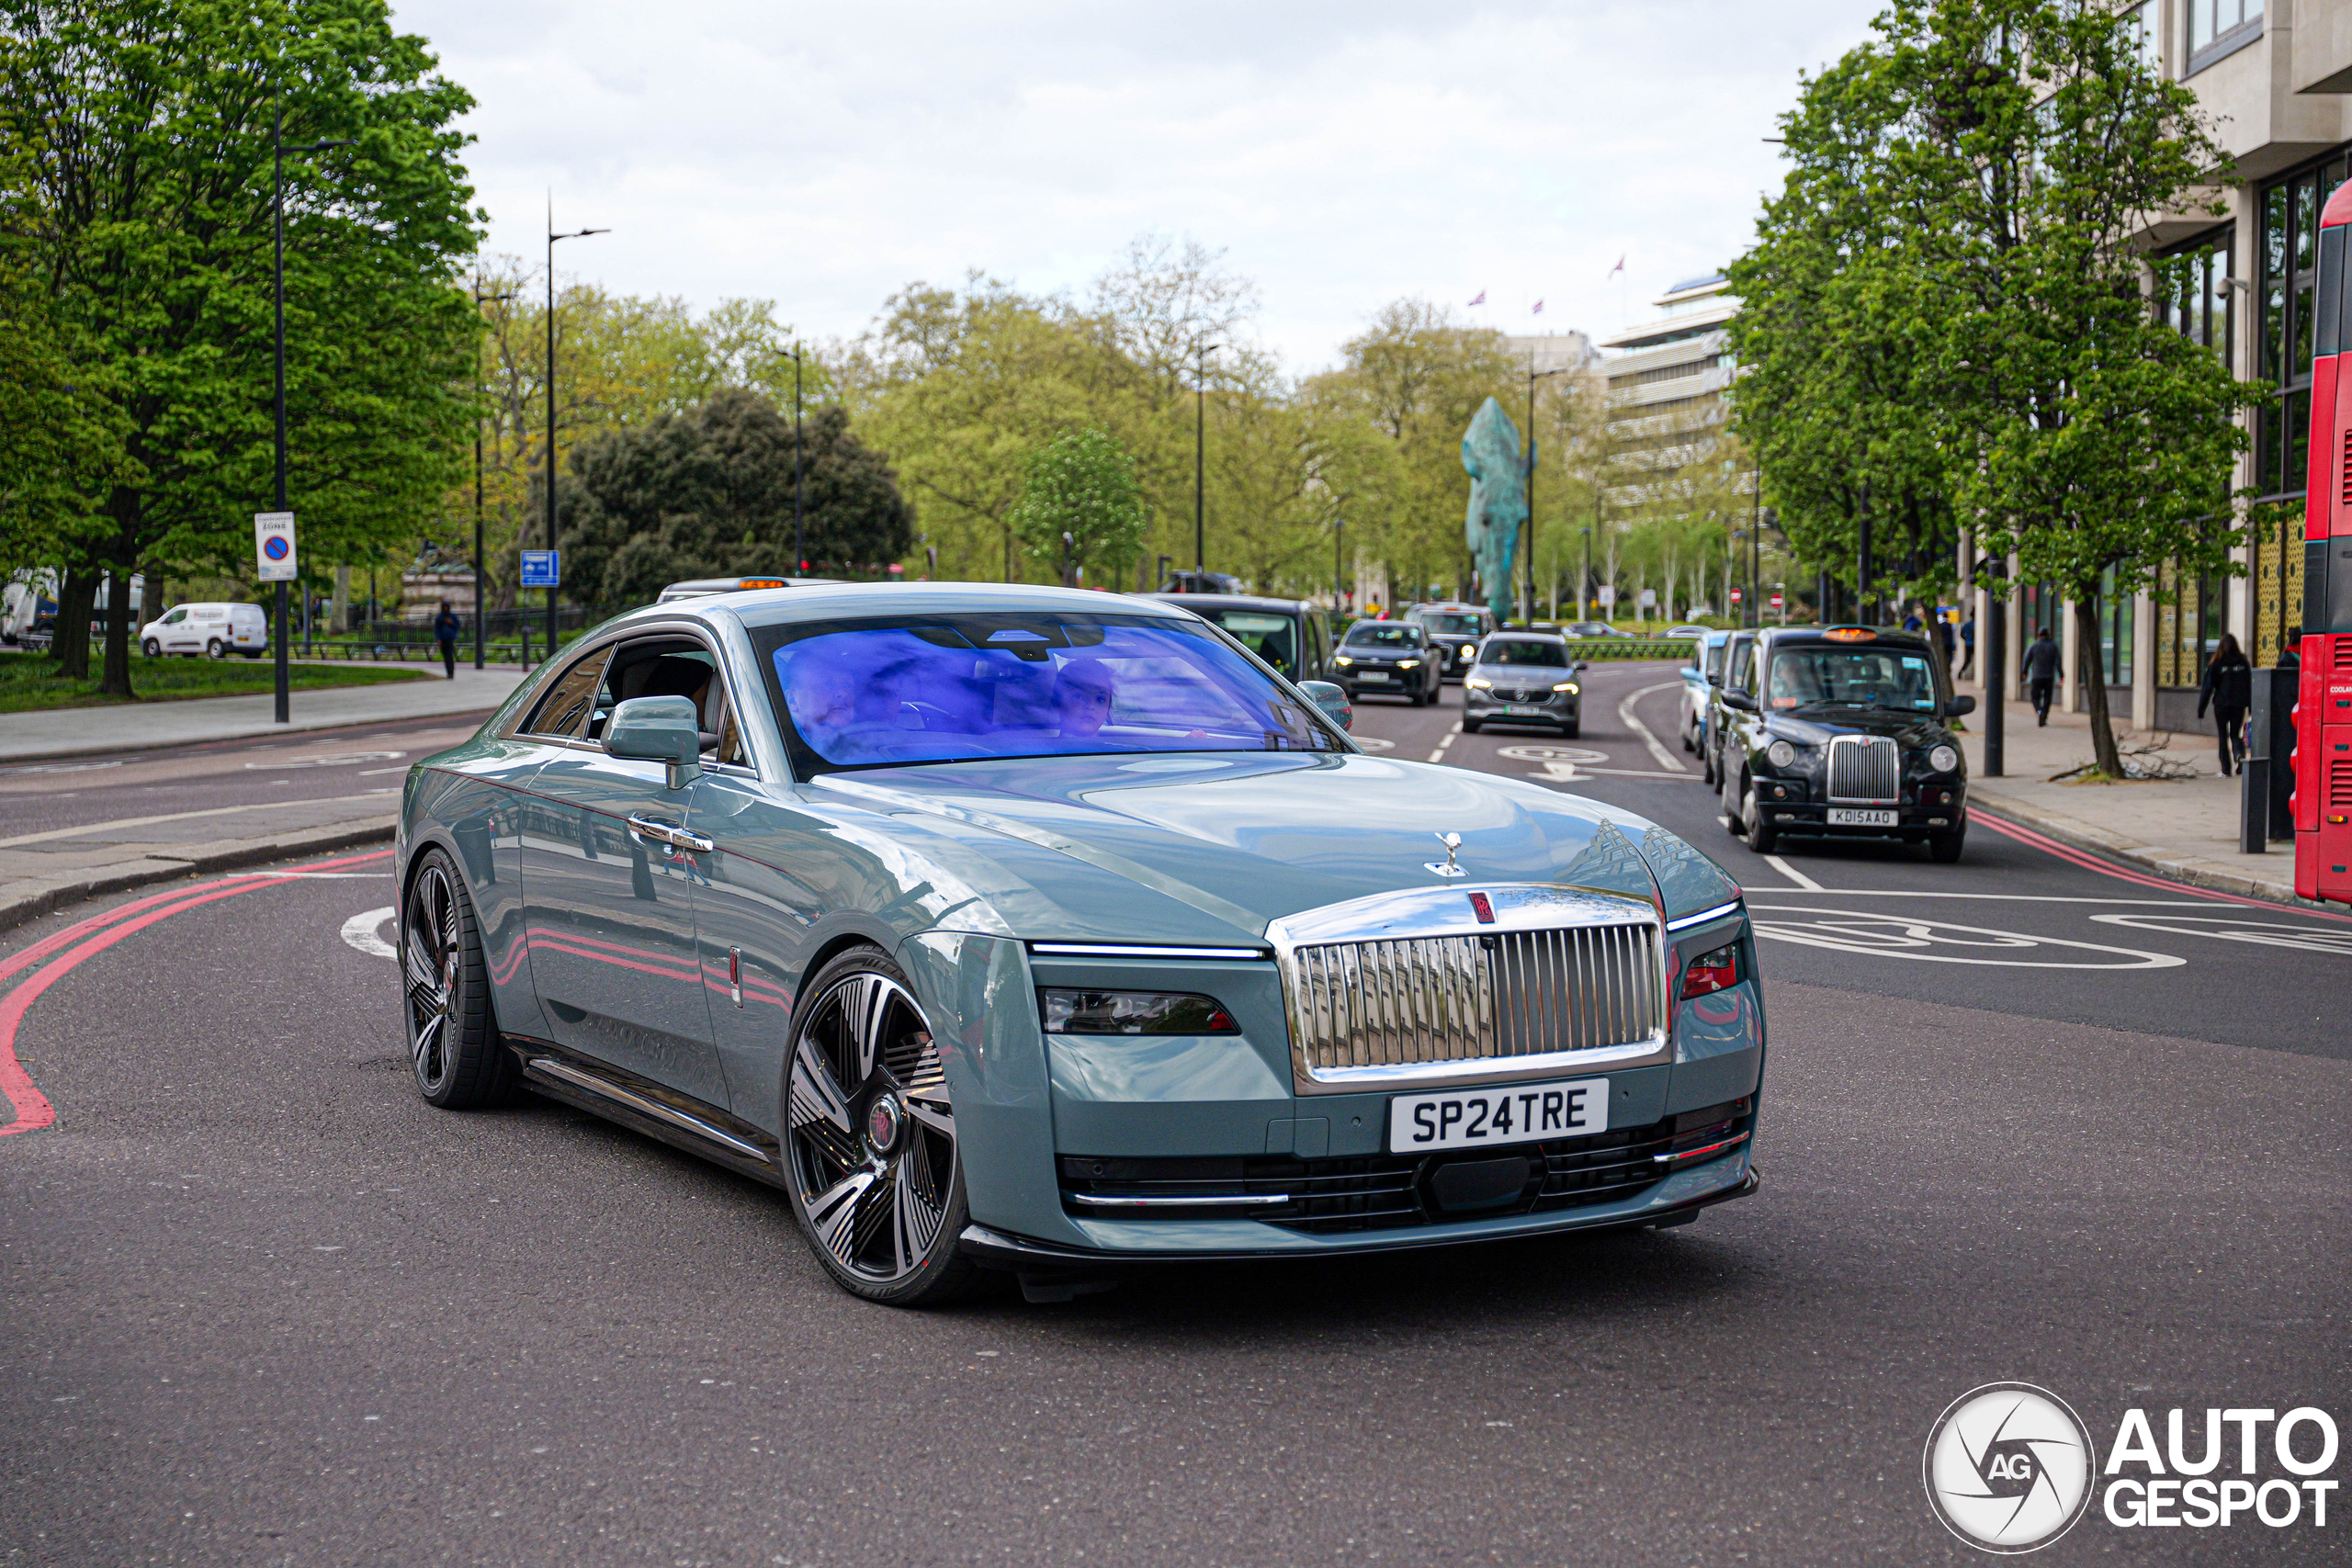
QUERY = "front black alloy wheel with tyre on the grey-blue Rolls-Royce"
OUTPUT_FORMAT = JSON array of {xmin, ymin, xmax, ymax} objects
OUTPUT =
[{"xmin": 783, "ymin": 947, "xmax": 974, "ymax": 1307}]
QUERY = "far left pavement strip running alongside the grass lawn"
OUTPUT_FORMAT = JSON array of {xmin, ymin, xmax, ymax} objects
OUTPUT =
[{"xmin": 0, "ymin": 665, "xmax": 537, "ymax": 764}]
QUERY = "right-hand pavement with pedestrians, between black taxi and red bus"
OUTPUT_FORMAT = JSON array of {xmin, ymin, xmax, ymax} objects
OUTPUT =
[{"xmin": 1959, "ymin": 682, "xmax": 2302, "ymax": 903}]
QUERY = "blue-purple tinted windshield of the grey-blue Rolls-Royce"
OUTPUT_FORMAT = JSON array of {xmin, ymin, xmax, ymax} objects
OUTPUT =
[{"xmin": 755, "ymin": 611, "xmax": 1345, "ymax": 776}]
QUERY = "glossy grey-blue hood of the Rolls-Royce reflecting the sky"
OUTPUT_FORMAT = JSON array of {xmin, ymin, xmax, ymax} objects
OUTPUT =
[{"xmin": 807, "ymin": 752, "xmax": 1738, "ymax": 942}]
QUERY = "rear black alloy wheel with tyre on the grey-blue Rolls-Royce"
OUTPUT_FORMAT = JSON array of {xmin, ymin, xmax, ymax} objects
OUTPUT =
[{"xmin": 400, "ymin": 849, "xmax": 517, "ymax": 1110}]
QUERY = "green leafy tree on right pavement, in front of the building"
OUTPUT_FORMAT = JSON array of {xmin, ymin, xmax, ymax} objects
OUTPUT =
[{"xmin": 1734, "ymin": 0, "xmax": 2251, "ymax": 776}]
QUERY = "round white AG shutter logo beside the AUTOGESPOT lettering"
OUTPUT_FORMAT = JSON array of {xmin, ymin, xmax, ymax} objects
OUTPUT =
[{"xmin": 1922, "ymin": 1382, "xmax": 2098, "ymax": 1554}]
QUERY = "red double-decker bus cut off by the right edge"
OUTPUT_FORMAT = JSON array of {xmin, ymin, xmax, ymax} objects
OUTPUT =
[{"xmin": 2293, "ymin": 184, "xmax": 2352, "ymax": 903}]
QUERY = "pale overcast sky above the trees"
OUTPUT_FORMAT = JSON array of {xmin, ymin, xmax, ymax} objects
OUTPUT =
[{"xmin": 395, "ymin": 0, "xmax": 1879, "ymax": 371}]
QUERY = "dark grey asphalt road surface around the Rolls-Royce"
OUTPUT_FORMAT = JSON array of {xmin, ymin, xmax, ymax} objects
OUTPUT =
[{"xmin": 0, "ymin": 665, "xmax": 2352, "ymax": 1565}]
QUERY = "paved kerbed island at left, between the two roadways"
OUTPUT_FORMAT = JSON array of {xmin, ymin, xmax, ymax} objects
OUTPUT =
[{"xmin": 0, "ymin": 790, "xmax": 400, "ymax": 931}]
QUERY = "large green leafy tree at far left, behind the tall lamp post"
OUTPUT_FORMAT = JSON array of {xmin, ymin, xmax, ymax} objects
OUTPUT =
[{"xmin": 0, "ymin": 0, "xmax": 475, "ymax": 694}]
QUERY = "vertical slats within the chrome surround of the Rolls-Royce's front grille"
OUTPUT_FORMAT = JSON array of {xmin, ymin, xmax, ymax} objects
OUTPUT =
[{"xmin": 1286, "ymin": 924, "xmax": 1665, "ymax": 1077}]
